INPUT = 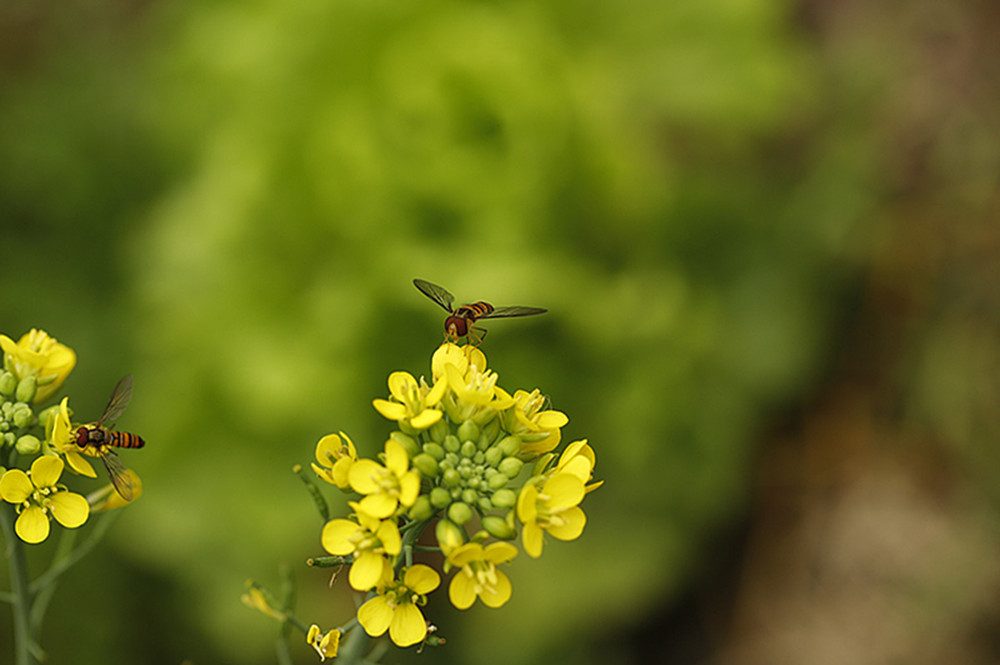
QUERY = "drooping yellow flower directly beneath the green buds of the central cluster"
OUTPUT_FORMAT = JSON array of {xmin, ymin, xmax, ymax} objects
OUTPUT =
[{"xmin": 445, "ymin": 543, "xmax": 517, "ymax": 610}]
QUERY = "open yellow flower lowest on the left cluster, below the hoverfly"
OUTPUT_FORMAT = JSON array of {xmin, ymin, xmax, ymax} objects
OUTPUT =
[{"xmin": 0, "ymin": 455, "xmax": 90, "ymax": 543}]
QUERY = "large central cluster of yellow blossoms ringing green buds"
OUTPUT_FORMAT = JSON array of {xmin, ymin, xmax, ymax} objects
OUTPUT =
[{"xmin": 307, "ymin": 342, "xmax": 601, "ymax": 658}]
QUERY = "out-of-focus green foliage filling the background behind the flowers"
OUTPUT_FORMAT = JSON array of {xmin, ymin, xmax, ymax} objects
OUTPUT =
[{"xmin": 0, "ymin": 0, "xmax": 995, "ymax": 663}]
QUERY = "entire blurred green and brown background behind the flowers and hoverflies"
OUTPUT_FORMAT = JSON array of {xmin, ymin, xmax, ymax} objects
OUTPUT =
[{"xmin": 0, "ymin": 0, "xmax": 1000, "ymax": 665}]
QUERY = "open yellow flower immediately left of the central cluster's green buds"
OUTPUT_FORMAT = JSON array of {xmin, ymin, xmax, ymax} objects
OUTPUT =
[{"xmin": 348, "ymin": 439, "xmax": 420, "ymax": 518}]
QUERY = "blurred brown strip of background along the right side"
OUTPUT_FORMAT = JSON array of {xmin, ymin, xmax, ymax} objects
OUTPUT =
[{"xmin": 720, "ymin": 1, "xmax": 1000, "ymax": 665}]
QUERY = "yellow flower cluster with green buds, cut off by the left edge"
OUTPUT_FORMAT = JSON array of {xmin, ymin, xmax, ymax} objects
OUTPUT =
[{"xmin": 0, "ymin": 329, "xmax": 139, "ymax": 544}]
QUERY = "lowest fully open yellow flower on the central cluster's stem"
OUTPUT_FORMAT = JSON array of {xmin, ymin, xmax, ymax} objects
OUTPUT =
[{"xmin": 358, "ymin": 563, "xmax": 441, "ymax": 647}]
